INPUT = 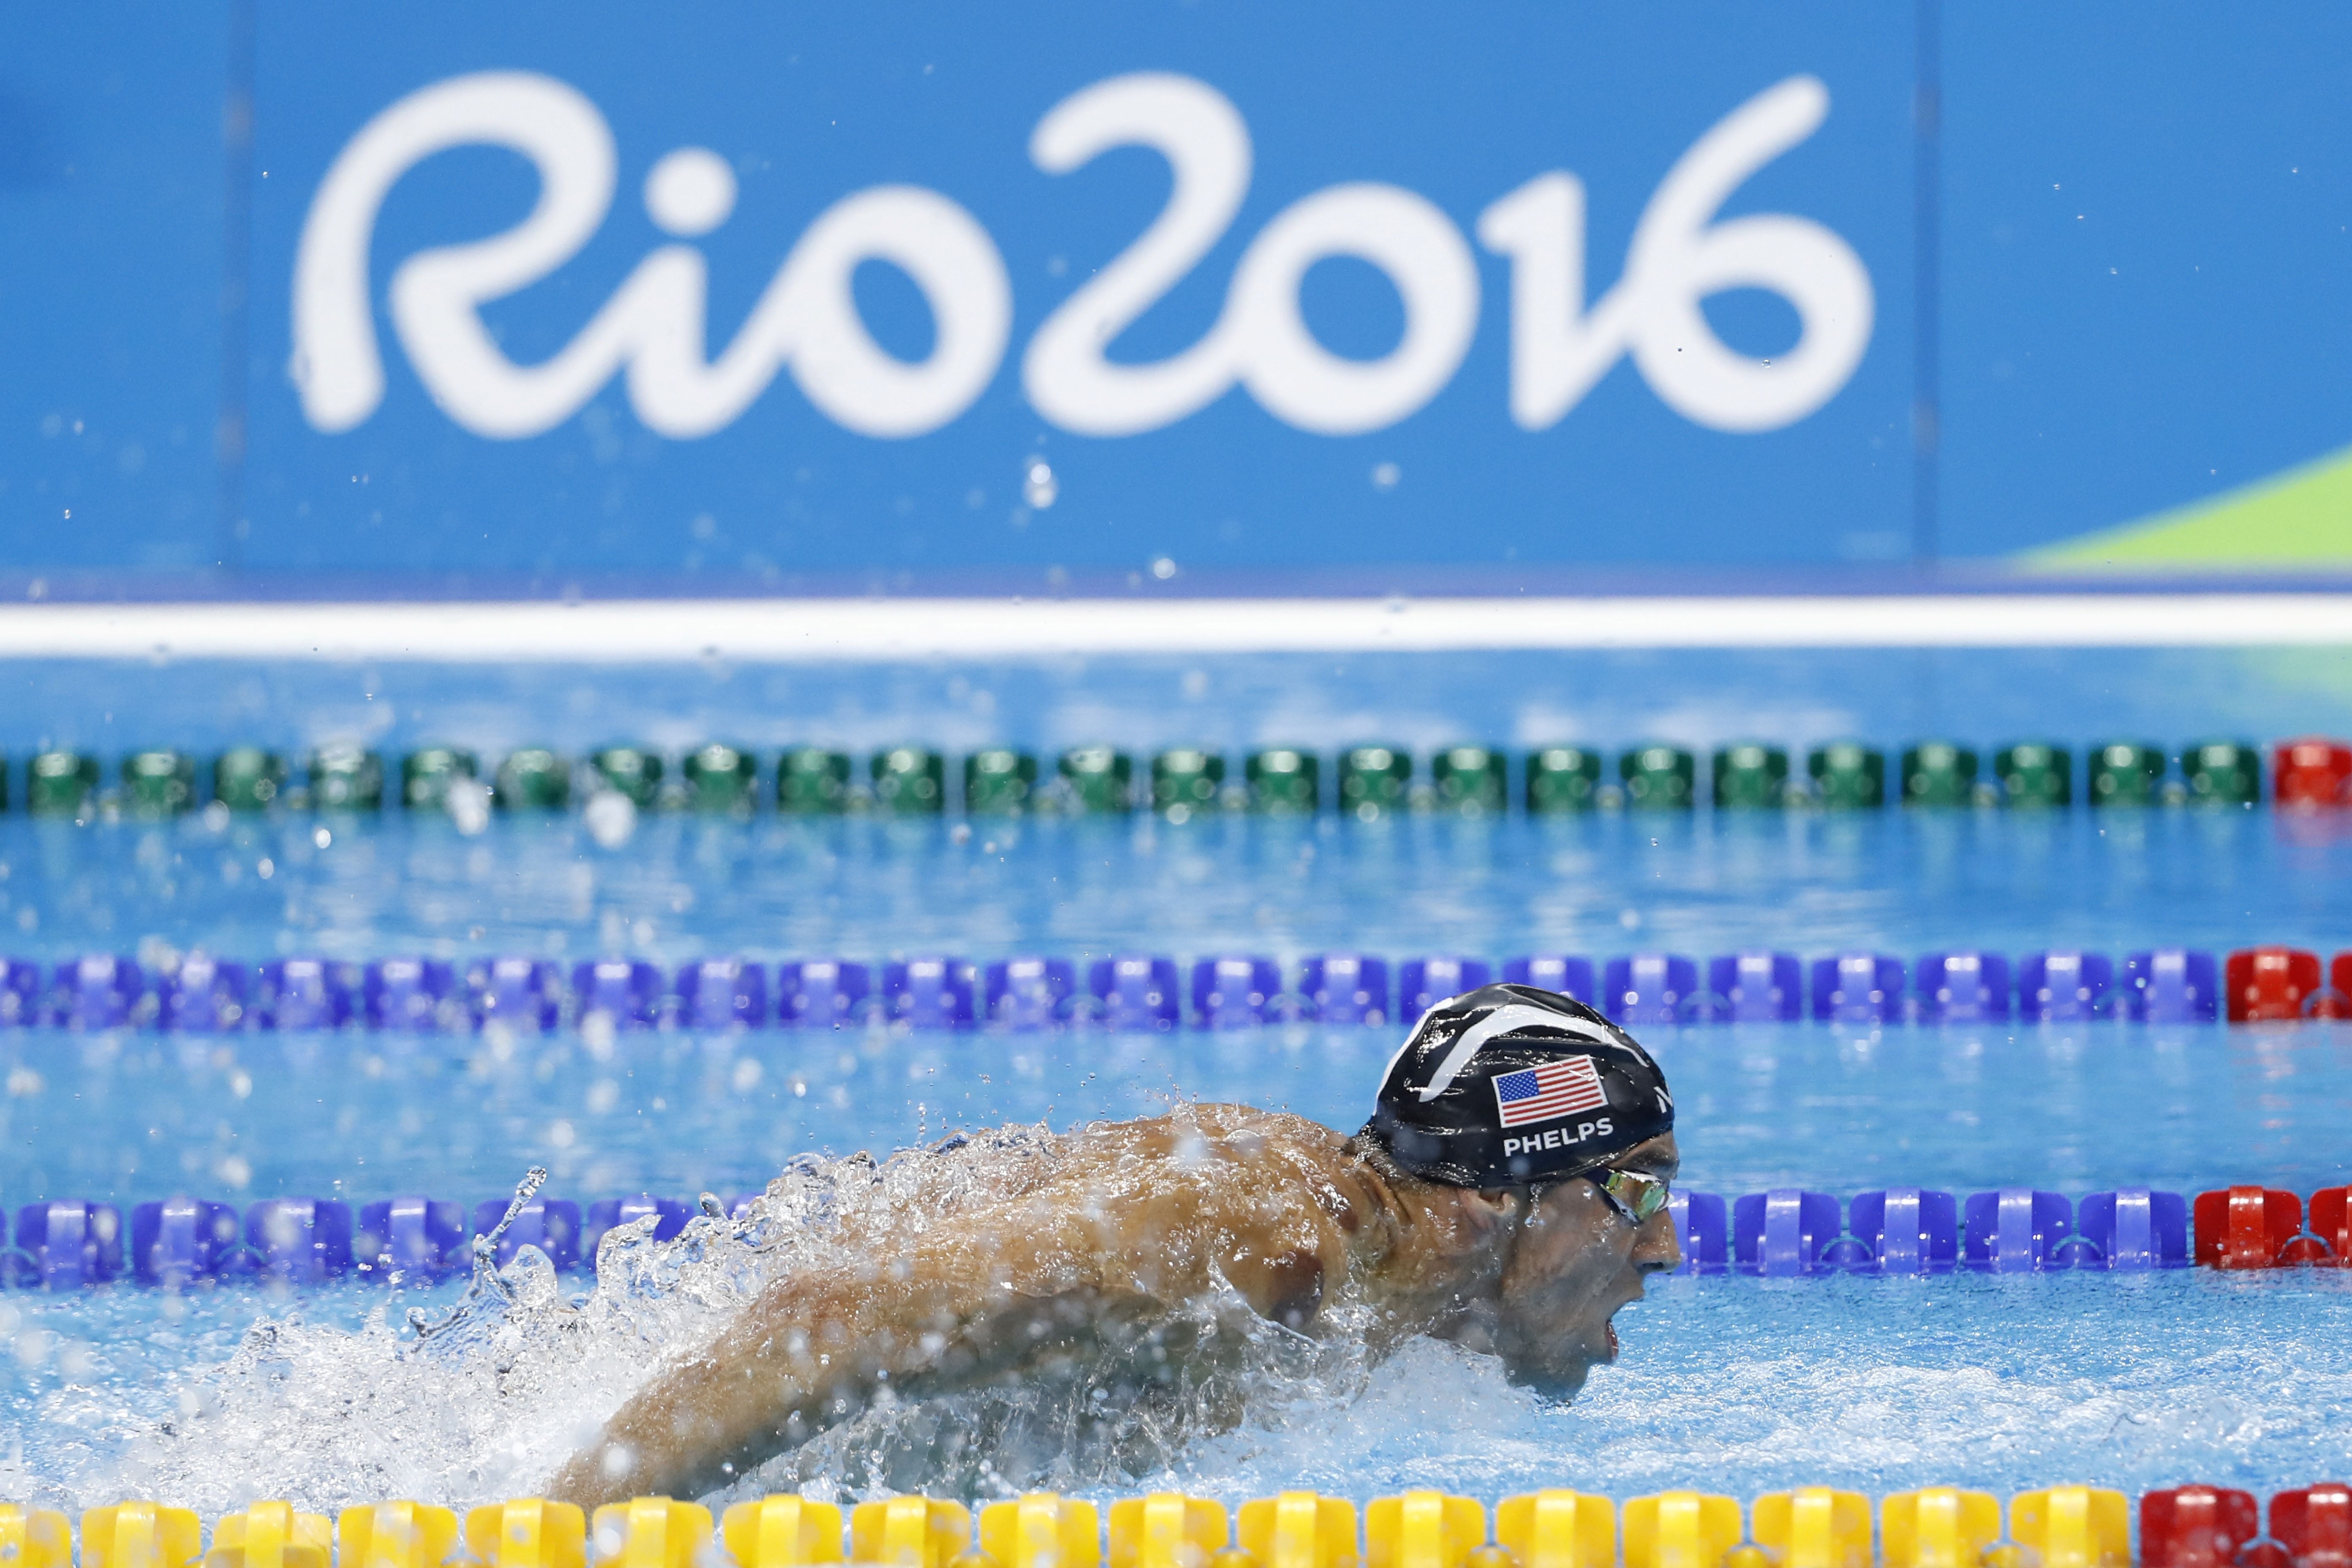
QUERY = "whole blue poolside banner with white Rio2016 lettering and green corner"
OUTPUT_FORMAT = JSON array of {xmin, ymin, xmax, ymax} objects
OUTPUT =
[{"xmin": 0, "ymin": 0, "xmax": 2352, "ymax": 592}]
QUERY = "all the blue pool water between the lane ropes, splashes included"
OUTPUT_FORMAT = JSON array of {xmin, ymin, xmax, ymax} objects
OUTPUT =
[{"xmin": 0, "ymin": 658, "xmax": 2352, "ymax": 1509}]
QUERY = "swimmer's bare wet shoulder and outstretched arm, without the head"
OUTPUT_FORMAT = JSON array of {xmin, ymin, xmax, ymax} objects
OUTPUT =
[{"xmin": 548, "ymin": 1105, "xmax": 1386, "ymax": 1505}]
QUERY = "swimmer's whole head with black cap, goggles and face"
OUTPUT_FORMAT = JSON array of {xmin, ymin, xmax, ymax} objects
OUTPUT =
[{"xmin": 1362, "ymin": 985, "xmax": 1682, "ymax": 1396}]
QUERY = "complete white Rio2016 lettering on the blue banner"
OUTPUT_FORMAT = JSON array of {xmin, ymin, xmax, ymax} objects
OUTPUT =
[{"xmin": 291, "ymin": 71, "xmax": 1872, "ymax": 440}]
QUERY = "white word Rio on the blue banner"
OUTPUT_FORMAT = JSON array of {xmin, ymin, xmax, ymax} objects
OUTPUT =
[{"xmin": 294, "ymin": 71, "xmax": 1011, "ymax": 440}]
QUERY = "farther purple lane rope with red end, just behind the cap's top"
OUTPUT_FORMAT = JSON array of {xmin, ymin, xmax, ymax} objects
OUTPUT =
[{"xmin": 14, "ymin": 945, "xmax": 2352, "ymax": 1034}]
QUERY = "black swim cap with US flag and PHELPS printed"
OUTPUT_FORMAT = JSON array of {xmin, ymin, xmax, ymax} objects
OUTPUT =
[{"xmin": 1362, "ymin": 985, "xmax": 1674, "ymax": 1187}]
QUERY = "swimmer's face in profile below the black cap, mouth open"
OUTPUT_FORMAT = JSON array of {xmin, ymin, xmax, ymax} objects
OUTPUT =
[{"xmin": 1496, "ymin": 1133, "xmax": 1682, "ymax": 1399}]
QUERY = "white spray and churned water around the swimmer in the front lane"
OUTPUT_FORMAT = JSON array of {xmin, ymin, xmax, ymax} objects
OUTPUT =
[{"xmin": 18, "ymin": 1128, "xmax": 2352, "ymax": 1511}]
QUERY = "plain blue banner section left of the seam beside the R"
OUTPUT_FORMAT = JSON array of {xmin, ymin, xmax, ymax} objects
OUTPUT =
[{"xmin": 0, "ymin": 5, "xmax": 242, "ymax": 571}]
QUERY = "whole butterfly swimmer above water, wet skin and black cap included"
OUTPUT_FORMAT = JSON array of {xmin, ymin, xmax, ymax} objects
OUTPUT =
[{"xmin": 548, "ymin": 985, "xmax": 1682, "ymax": 1505}]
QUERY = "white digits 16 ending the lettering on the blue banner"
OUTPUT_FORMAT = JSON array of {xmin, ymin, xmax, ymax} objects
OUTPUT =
[{"xmin": 1477, "ymin": 75, "xmax": 1872, "ymax": 430}]
